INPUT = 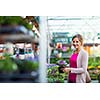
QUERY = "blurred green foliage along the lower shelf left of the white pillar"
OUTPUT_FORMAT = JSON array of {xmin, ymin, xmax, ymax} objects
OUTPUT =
[{"xmin": 0, "ymin": 54, "xmax": 39, "ymax": 73}]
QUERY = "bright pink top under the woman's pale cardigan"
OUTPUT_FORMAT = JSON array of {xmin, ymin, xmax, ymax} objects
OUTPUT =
[{"xmin": 69, "ymin": 53, "xmax": 78, "ymax": 83}]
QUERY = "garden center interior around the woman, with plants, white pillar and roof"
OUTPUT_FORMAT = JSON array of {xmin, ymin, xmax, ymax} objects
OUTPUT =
[{"xmin": 0, "ymin": 16, "xmax": 100, "ymax": 83}]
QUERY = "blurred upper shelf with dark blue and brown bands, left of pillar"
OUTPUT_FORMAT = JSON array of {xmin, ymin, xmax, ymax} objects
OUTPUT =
[{"xmin": 0, "ymin": 26, "xmax": 38, "ymax": 44}]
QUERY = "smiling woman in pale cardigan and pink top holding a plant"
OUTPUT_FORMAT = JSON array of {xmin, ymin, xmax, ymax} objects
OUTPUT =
[{"xmin": 63, "ymin": 34, "xmax": 88, "ymax": 83}]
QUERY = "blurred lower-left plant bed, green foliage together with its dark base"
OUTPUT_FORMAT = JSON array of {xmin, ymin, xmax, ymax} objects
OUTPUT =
[{"xmin": 0, "ymin": 56, "xmax": 39, "ymax": 83}]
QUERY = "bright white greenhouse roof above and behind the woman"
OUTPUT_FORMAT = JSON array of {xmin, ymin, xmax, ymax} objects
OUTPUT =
[{"xmin": 47, "ymin": 16, "xmax": 100, "ymax": 43}]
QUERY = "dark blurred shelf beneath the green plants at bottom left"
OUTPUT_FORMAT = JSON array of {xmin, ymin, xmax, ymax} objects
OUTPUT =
[{"xmin": 0, "ymin": 72, "xmax": 38, "ymax": 83}]
